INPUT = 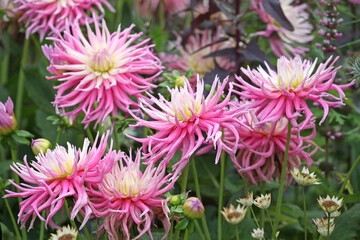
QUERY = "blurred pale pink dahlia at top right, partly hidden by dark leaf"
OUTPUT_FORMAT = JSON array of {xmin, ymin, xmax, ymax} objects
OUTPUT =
[{"xmin": 251, "ymin": 0, "xmax": 314, "ymax": 57}]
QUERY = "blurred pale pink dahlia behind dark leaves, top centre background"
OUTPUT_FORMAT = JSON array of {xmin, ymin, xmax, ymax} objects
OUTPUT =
[{"xmin": 160, "ymin": 28, "xmax": 234, "ymax": 87}]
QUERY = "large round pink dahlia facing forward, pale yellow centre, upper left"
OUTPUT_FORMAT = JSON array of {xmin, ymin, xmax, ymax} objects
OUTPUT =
[{"xmin": 43, "ymin": 21, "xmax": 162, "ymax": 127}]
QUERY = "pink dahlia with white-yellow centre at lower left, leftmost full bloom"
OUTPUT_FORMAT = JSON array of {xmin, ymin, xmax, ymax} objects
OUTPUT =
[{"xmin": 5, "ymin": 132, "xmax": 114, "ymax": 229}]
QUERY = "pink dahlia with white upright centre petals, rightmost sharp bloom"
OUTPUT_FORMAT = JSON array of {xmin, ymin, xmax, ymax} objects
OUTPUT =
[{"xmin": 235, "ymin": 56, "xmax": 354, "ymax": 129}]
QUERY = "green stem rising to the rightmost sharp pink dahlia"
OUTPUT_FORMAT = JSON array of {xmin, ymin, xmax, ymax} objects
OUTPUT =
[{"xmin": 272, "ymin": 120, "xmax": 291, "ymax": 237}]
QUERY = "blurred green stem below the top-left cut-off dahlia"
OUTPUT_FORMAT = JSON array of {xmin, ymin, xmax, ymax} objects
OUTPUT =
[{"xmin": 15, "ymin": 38, "xmax": 29, "ymax": 125}]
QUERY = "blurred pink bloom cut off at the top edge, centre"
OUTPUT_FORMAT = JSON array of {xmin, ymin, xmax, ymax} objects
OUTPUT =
[{"xmin": 134, "ymin": 0, "xmax": 191, "ymax": 16}]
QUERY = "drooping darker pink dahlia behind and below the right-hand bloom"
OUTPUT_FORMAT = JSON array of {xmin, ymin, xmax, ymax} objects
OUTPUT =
[{"xmin": 225, "ymin": 109, "xmax": 317, "ymax": 184}]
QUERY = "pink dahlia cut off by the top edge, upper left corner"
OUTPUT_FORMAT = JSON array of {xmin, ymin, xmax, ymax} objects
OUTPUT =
[{"xmin": 16, "ymin": 0, "xmax": 115, "ymax": 40}]
